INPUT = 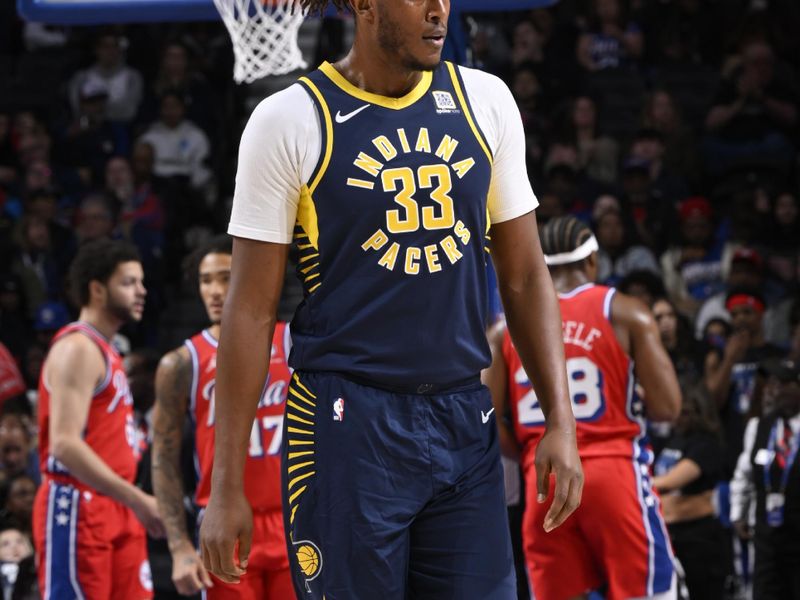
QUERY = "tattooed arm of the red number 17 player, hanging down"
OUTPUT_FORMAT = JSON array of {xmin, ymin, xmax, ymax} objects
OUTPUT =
[{"xmin": 153, "ymin": 347, "xmax": 212, "ymax": 596}]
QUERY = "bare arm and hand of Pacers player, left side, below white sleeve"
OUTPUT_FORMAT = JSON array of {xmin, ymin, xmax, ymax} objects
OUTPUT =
[{"xmin": 200, "ymin": 237, "xmax": 289, "ymax": 583}]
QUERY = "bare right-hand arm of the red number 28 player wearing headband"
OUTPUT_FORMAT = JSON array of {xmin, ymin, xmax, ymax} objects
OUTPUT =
[{"xmin": 611, "ymin": 293, "xmax": 681, "ymax": 421}]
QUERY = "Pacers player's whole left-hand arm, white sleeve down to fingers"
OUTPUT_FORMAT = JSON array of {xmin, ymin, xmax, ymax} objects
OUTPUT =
[{"xmin": 200, "ymin": 84, "xmax": 310, "ymax": 582}]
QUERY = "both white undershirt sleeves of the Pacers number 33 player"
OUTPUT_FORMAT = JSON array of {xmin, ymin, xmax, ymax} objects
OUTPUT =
[{"xmin": 228, "ymin": 67, "xmax": 538, "ymax": 244}]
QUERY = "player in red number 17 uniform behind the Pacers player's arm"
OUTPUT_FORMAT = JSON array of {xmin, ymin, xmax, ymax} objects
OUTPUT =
[{"xmin": 153, "ymin": 236, "xmax": 294, "ymax": 600}]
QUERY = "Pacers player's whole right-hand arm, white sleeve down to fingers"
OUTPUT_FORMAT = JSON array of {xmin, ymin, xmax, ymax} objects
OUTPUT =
[{"xmin": 462, "ymin": 69, "xmax": 583, "ymax": 530}]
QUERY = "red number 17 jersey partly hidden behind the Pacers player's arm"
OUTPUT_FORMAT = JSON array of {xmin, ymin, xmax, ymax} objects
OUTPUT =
[{"xmin": 185, "ymin": 322, "xmax": 291, "ymax": 510}]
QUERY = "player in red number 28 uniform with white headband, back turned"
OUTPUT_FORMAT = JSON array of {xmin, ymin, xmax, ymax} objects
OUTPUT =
[{"xmin": 485, "ymin": 217, "xmax": 680, "ymax": 600}]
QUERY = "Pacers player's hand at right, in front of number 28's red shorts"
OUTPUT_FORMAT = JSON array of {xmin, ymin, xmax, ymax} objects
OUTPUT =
[{"xmin": 536, "ymin": 427, "xmax": 583, "ymax": 532}]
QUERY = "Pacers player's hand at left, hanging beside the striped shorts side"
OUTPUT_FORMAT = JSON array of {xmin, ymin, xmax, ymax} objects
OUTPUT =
[{"xmin": 200, "ymin": 488, "xmax": 253, "ymax": 583}]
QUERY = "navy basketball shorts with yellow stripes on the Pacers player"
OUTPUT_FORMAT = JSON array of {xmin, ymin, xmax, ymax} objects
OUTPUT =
[{"xmin": 282, "ymin": 373, "xmax": 516, "ymax": 600}]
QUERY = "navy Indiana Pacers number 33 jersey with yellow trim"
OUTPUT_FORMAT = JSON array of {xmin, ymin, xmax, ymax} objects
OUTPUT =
[{"xmin": 290, "ymin": 63, "xmax": 492, "ymax": 389}]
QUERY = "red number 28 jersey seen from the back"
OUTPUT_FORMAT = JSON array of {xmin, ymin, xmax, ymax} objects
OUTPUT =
[{"xmin": 503, "ymin": 284, "xmax": 651, "ymax": 472}]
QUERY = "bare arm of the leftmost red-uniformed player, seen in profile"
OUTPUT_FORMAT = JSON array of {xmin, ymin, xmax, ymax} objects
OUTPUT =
[{"xmin": 45, "ymin": 333, "xmax": 164, "ymax": 537}]
